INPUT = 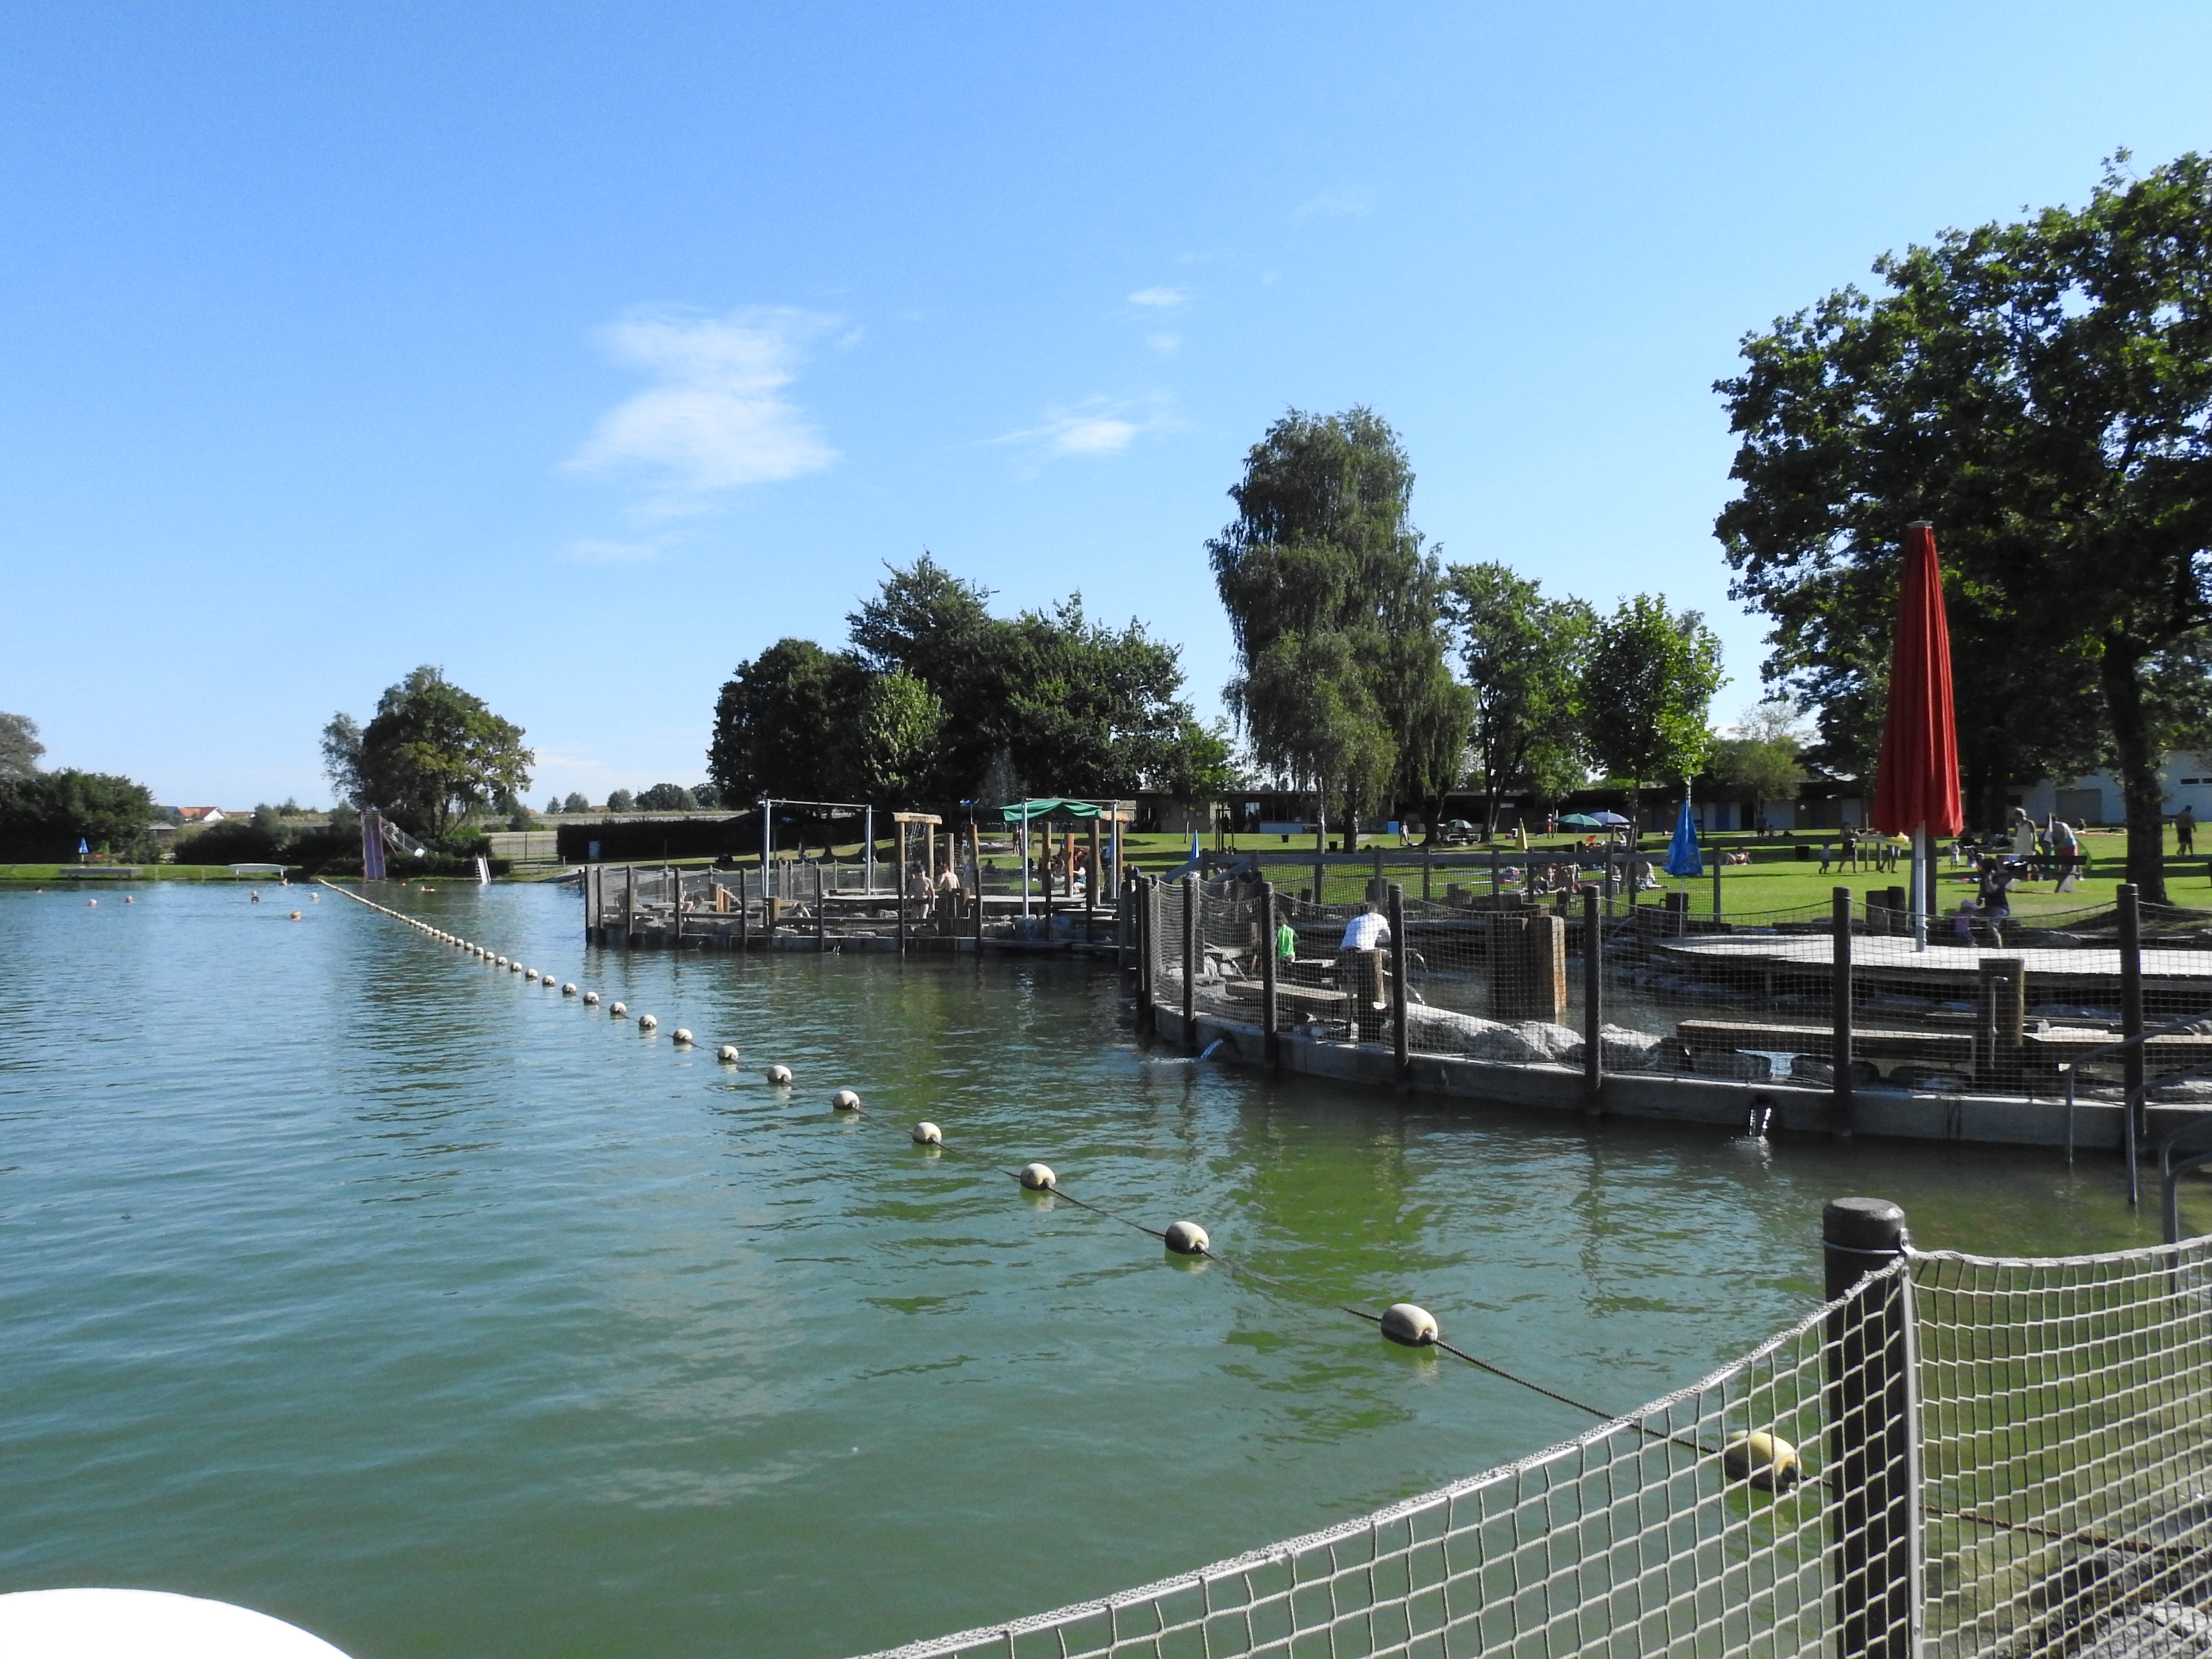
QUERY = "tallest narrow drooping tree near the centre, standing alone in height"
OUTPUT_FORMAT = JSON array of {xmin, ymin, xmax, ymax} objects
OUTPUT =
[{"xmin": 1205, "ymin": 407, "xmax": 1471, "ymax": 849}]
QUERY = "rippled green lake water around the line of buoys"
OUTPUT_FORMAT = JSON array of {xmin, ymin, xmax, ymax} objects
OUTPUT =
[{"xmin": 0, "ymin": 885, "xmax": 2157, "ymax": 1659}]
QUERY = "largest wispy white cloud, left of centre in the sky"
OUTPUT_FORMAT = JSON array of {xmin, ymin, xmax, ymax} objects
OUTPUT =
[{"xmin": 568, "ymin": 305, "xmax": 836, "ymax": 497}]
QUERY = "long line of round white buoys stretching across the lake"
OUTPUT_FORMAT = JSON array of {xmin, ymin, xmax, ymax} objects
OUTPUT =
[{"xmin": 316, "ymin": 876, "xmax": 1787, "ymax": 1493}]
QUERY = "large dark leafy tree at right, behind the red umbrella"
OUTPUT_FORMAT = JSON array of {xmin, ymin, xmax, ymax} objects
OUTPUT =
[{"xmin": 1717, "ymin": 155, "xmax": 2212, "ymax": 902}]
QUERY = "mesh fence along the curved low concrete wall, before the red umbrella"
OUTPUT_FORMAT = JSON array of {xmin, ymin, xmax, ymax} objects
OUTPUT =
[{"xmin": 1139, "ymin": 876, "xmax": 2212, "ymax": 1104}]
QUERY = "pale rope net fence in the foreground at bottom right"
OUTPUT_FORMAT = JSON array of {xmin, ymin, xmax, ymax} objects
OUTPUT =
[{"xmin": 854, "ymin": 1241, "xmax": 2212, "ymax": 1659}]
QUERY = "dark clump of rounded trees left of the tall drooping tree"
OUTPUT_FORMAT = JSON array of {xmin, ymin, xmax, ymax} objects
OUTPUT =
[{"xmin": 708, "ymin": 553, "xmax": 1234, "ymax": 803}]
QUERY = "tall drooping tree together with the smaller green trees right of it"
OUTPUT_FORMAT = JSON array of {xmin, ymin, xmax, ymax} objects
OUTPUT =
[{"xmin": 1208, "ymin": 407, "xmax": 1721, "ymax": 845}]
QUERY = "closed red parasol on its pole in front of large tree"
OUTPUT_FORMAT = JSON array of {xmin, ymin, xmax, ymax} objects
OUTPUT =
[{"xmin": 1874, "ymin": 522, "xmax": 1967, "ymax": 945}]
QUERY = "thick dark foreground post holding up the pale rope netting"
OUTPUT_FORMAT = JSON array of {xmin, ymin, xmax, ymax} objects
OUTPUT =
[{"xmin": 1820, "ymin": 1199, "xmax": 1922, "ymax": 1659}]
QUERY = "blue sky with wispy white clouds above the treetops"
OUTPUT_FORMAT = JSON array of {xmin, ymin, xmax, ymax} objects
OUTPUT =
[{"xmin": 0, "ymin": 0, "xmax": 2212, "ymax": 805}]
